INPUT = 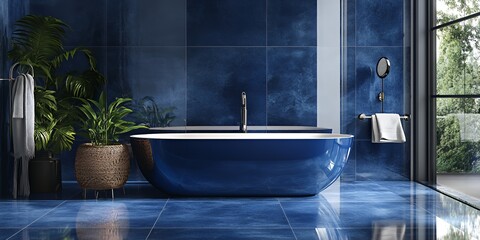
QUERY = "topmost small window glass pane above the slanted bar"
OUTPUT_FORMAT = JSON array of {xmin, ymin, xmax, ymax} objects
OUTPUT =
[{"xmin": 436, "ymin": 0, "xmax": 480, "ymax": 25}]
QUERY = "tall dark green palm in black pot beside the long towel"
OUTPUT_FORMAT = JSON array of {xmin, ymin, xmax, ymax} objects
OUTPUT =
[{"xmin": 8, "ymin": 15, "xmax": 105, "ymax": 193}]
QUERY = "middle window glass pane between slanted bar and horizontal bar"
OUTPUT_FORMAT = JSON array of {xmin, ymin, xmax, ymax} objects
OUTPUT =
[{"xmin": 436, "ymin": 18, "xmax": 480, "ymax": 94}]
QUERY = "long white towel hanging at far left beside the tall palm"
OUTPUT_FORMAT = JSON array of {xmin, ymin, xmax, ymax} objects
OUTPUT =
[{"xmin": 12, "ymin": 74, "xmax": 35, "ymax": 198}]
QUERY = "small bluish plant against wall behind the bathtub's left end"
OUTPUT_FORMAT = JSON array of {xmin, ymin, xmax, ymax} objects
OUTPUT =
[{"xmin": 133, "ymin": 96, "xmax": 176, "ymax": 127}]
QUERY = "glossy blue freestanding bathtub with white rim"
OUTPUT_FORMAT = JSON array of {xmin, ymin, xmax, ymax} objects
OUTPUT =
[{"xmin": 130, "ymin": 133, "xmax": 353, "ymax": 196}]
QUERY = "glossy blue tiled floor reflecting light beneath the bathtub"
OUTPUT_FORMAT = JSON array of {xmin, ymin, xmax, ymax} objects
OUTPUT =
[{"xmin": 0, "ymin": 181, "xmax": 480, "ymax": 240}]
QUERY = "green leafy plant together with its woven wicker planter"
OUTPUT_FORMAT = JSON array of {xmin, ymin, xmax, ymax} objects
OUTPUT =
[{"xmin": 75, "ymin": 92, "xmax": 146, "ymax": 197}]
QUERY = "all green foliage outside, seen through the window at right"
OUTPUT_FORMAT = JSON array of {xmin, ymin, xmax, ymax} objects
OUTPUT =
[{"xmin": 436, "ymin": 0, "xmax": 480, "ymax": 173}]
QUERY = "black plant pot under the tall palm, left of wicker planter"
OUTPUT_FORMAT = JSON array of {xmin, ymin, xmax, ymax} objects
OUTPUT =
[{"xmin": 28, "ymin": 152, "xmax": 62, "ymax": 193}]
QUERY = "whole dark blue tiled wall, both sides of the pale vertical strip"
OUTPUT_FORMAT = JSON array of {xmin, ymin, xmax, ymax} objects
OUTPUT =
[{"xmin": 26, "ymin": 0, "xmax": 409, "ymax": 180}]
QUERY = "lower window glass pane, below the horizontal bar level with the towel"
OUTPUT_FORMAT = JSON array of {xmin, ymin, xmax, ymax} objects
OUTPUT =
[{"xmin": 436, "ymin": 98, "xmax": 480, "ymax": 173}]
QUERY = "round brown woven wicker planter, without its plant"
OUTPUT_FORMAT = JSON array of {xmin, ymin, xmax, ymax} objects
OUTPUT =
[{"xmin": 75, "ymin": 143, "xmax": 130, "ymax": 190}]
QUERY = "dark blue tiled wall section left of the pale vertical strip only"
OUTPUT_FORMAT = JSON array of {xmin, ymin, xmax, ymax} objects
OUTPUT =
[{"xmin": 30, "ymin": 0, "xmax": 320, "ymax": 180}]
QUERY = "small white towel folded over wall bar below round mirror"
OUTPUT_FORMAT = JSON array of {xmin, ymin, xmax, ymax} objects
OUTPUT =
[{"xmin": 372, "ymin": 113, "xmax": 406, "ymax": 143}]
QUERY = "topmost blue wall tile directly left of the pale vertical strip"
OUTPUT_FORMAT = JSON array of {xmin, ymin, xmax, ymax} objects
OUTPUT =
[{"xmin": 267, "ymin": 0, "xmax": 317, "ymax": 46}]
